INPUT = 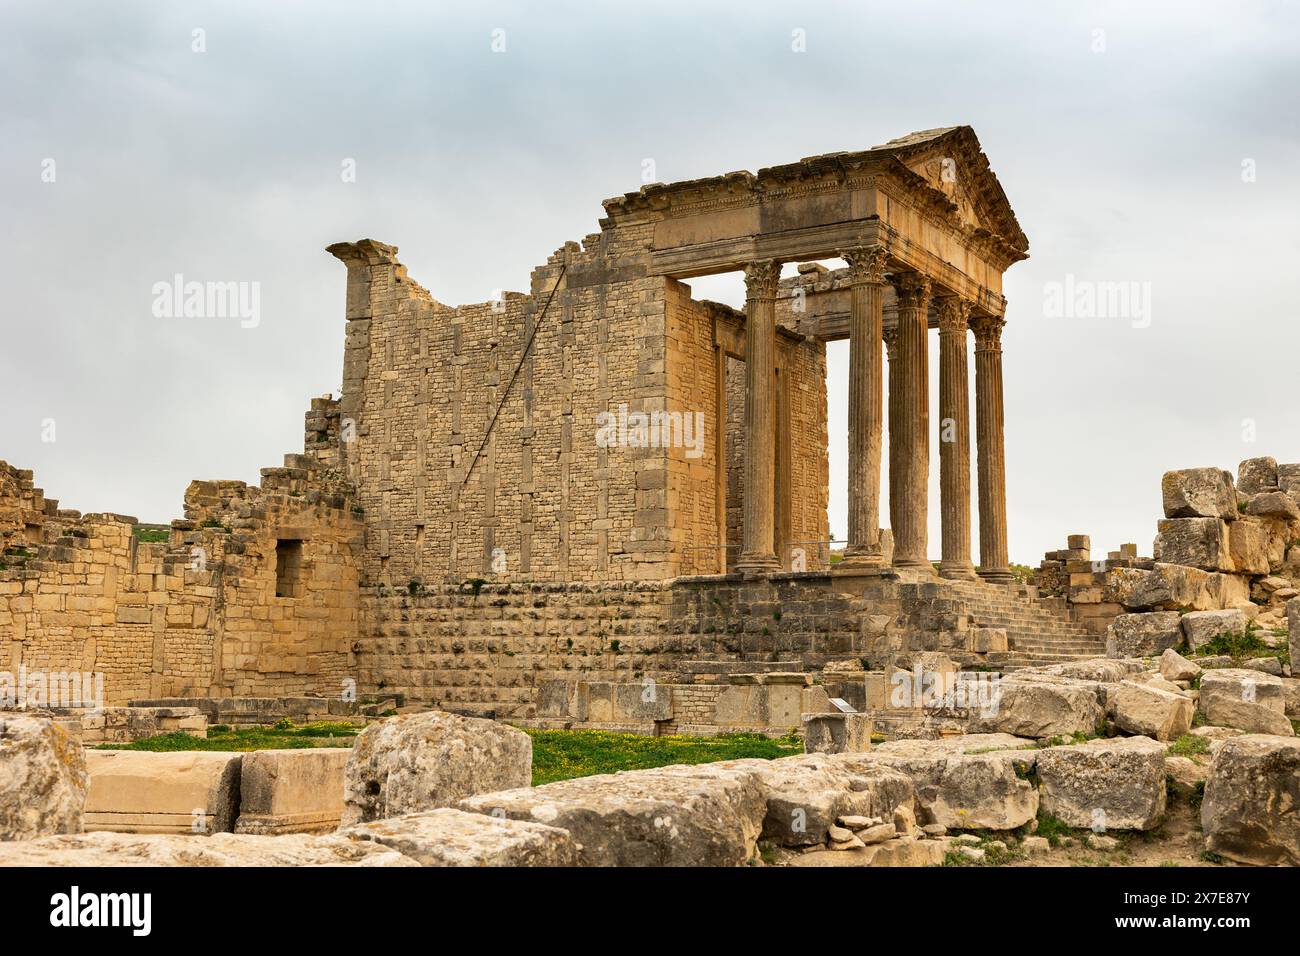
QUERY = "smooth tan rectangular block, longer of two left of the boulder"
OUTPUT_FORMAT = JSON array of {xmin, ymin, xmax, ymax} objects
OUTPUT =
[{"xmin": 85, "ymin": 750, "xmax": 243, "ymax": 835}]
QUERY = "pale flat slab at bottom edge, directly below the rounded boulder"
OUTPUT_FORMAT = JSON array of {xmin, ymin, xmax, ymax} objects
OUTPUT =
[{"xmin": 339, "ymin": 806, "xmax": 579, "ymax": 866}]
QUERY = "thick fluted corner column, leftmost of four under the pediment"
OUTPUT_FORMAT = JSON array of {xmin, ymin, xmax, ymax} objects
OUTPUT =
[{"xmin": 840, "ymin": 246, "xmax": 885, "ymax": 571}]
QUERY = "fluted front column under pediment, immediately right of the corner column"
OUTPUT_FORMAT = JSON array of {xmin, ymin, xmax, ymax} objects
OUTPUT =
[{"xmin": 889, "ymin": 272, "xmax": 930, "ymax": 568}]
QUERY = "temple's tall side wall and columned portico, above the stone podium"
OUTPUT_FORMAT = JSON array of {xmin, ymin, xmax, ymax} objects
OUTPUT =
[{"xmin": 321, "ymin": 127, "xmax": 1027, "ymax": 581}]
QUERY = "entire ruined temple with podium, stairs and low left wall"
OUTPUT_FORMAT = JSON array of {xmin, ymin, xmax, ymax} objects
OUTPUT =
[{"xmin": 0, "ymin": 126, "xmax": 1118, "ymax": 728}]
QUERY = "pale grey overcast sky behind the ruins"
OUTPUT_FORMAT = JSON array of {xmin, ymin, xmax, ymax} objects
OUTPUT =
[{"xmin": 0, "ymin": 0, "xmax": 1300, "ymax": 564}]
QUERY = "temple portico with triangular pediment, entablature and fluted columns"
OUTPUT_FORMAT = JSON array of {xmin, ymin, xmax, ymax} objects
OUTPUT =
[{"xmin": 606, "ymin": 126, "xmax": 1028, "ymax": 581}]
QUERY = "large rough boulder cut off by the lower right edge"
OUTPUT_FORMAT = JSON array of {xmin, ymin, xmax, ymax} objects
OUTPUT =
[{"xmin": 1201, "ymin": 734, "xmax": 1300, "ymax": 866}]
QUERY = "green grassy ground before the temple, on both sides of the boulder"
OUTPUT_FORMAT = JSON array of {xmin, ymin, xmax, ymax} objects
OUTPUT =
[{"xmin": 99, "ymin": 721, "xmax": 803, "ymax": 786}]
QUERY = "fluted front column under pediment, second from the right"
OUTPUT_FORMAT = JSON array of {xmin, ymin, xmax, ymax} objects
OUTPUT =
[{"xmin": 939, "ymin": 295, "xmax": 975, "ymax": 578}]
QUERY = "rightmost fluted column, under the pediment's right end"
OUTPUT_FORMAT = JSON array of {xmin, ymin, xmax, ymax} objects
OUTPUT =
[{"xmin": 971, "ymin": 316, "xmax": 1011, "ymax": 584}]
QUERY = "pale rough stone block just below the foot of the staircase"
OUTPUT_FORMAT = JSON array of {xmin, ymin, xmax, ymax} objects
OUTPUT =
[{"xmin": 967, "ymin": 674, "xmax": 1105, "ymax": 739}]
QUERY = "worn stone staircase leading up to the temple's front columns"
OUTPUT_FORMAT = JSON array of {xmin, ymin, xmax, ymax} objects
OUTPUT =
[{"xmin": 925, "ymin": 581, "xmax": 1106, "ymax": 670}]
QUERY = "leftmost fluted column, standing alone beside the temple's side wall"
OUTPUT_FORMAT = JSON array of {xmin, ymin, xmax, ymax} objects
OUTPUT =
[{"xmin": 736, "ymin": 260, "xmax": 781, "ymax": 574}]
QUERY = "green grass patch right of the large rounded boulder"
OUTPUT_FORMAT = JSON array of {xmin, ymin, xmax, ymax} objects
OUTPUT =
[{"xmin": 527, "ymin": 730, "xmax": 803, "ymax": 787}]
